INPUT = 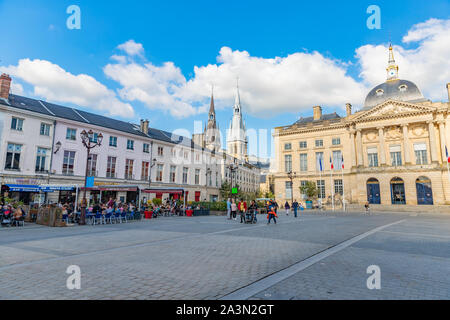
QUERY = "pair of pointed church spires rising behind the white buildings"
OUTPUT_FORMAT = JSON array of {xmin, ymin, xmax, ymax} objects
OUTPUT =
[{"xmin": 192, "ymin": 85, "xmax": 248, "ymax": 161}]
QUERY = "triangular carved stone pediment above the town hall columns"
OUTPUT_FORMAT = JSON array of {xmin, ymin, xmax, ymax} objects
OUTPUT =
[{"xmin": 353, "ymin": 100, "xmax": 436, "ymax": 121}]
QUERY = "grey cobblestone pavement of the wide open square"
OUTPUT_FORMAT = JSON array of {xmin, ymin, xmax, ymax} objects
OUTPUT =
[{"xmin": 0, "ymin": 213, "xmax": 450, "ymax": 299}]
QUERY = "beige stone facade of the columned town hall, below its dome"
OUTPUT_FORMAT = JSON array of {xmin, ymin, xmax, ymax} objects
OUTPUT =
[{"xmin": 274, "ymin": 94, "xmax": 450, "ymax": 205}]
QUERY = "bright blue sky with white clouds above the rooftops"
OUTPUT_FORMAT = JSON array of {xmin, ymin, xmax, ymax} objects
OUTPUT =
[{"xmin": 0, "ymin": 0, "xmax": 450, "ymax": 159}]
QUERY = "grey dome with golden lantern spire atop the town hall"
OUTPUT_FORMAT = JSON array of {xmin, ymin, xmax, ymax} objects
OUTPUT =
[{"xmin": 363, "ymin": 45, "xmax": 426, "ymax": 110}]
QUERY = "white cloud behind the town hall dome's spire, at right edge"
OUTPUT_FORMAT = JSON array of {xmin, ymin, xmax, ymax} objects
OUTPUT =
[{"xmin": 356, "ymin": 19, "xmax": 450, "ymax": 101}]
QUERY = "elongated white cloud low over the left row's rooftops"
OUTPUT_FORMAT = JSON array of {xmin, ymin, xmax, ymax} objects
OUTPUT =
[{"xmin": 0, "ymin": 59, "xmax": 134, "ymax": 118}]
